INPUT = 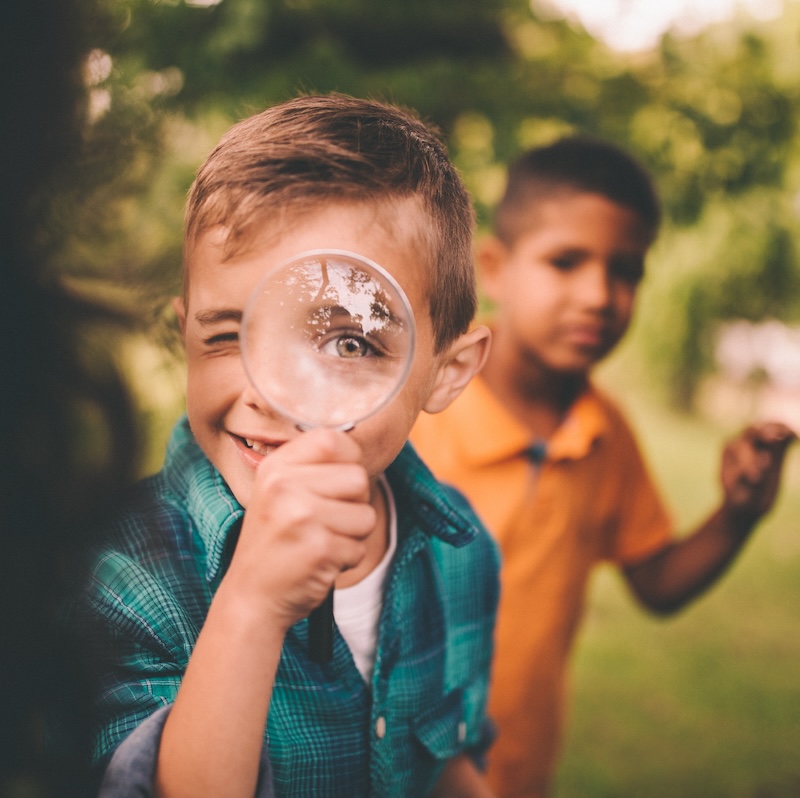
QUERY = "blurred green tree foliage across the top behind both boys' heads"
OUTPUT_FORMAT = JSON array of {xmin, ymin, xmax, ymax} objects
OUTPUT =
[{"xmin": 48, "ymin": 0, "xmax": 800, "ymax": 406}]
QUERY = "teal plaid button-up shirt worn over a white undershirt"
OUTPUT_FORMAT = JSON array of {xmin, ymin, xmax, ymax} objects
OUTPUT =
[{"xmin": 79, "ymin": 419, "xmax": 498, "ymax": 798}]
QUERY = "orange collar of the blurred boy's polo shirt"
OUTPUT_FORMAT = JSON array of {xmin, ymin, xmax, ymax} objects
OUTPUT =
[{"xmin": 450, "ymin": 376, "xmax": 608, "ymax": 466}]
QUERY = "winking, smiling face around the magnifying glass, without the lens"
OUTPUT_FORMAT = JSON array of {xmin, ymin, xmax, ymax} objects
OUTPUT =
[{"xmin": 179, "ymin": 201, "xmax": 446, "ymax": 507}]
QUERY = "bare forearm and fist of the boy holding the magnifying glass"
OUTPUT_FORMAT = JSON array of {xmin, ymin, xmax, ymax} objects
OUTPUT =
[{"xmin": 156, "ymin": 430, "xmax": 376, "ymax": 798}]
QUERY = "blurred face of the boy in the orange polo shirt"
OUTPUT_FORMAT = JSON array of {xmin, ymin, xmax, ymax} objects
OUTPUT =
[{"xmin": 483, "ymin": 193, "xmax": 650, "ymax": 382}]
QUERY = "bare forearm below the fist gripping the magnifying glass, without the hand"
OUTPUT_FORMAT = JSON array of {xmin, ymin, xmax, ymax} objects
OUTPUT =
[{"xmin": 155, "ymin": 581, "xmax": 285, "ymax": 798}]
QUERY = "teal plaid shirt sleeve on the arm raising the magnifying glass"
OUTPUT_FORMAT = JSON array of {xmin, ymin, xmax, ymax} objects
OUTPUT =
[{"xmin": 77, "ymin": 484, "xmax": 210, "ymax": 762}]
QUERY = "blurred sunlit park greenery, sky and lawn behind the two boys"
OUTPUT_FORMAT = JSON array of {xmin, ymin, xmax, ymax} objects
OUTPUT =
[{"xmin": 20, "ymin": 0, "xmax": 800, "ymax": 798}]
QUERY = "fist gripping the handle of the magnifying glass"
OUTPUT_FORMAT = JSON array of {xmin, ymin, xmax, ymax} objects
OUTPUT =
[{"xmin": 225, "ymin": 429, "xmax": 377, "ymax": 629}]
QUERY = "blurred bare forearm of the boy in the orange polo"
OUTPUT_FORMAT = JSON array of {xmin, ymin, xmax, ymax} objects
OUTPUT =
[{"xmin": 624, "ymin": 506, "xmax": 758, "ymax": 614}]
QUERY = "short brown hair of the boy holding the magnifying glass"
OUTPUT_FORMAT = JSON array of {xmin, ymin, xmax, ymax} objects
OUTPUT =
[{"xmin": 185, "ymin": 94, "xmax": 476, "ymax": 351}]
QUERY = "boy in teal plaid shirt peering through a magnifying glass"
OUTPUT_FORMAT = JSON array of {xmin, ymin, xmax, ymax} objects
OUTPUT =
[{"xmin": 73, "ymin": 95, "xmax": 498, "ymax": 798}]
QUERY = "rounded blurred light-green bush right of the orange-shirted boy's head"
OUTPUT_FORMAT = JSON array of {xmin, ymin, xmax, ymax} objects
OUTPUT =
[{"xmin": 639, "ymin": 188, "xmax": 800, "ymax": 410}]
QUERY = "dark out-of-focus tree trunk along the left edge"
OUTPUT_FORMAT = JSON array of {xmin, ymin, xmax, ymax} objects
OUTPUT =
[{"xmin": 0, "ymin": 0, "xmax": 139, "ymax": 798}]
